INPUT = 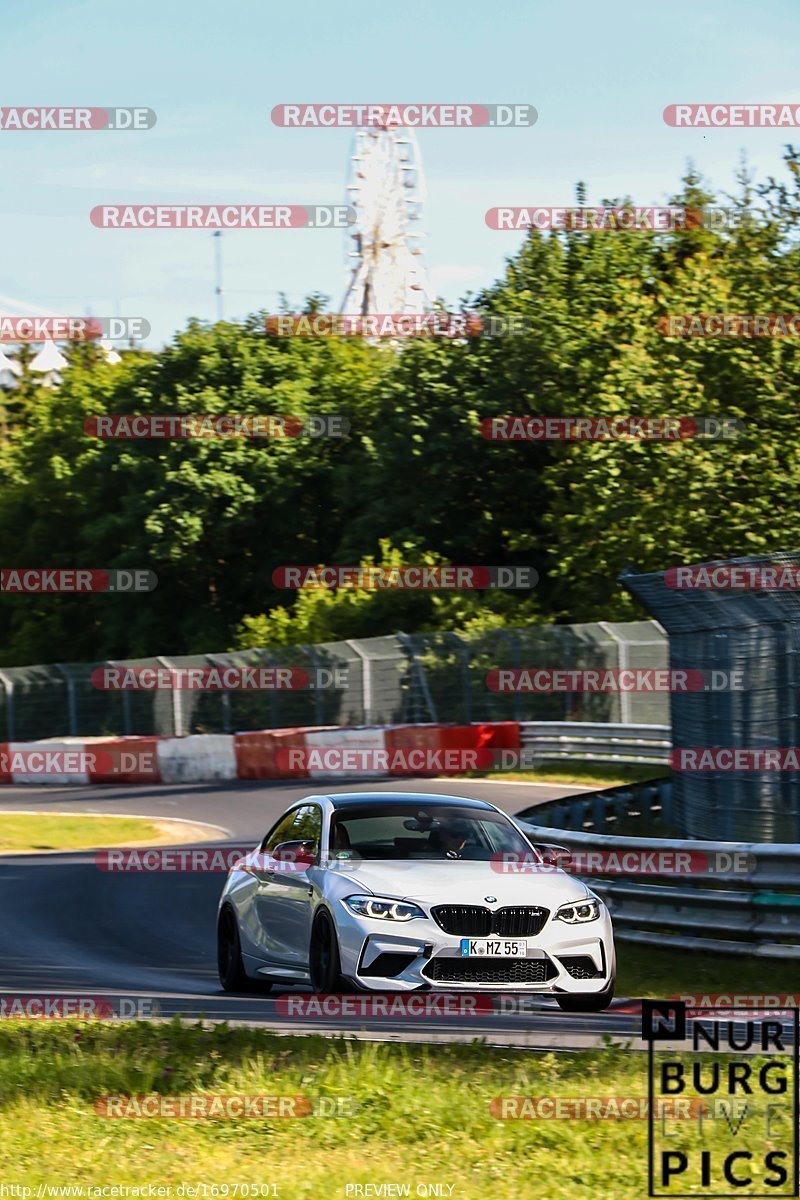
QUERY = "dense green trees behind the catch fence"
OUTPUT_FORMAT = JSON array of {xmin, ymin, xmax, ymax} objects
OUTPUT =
[{"xmin": 0, "ymin": 148, "xmax": 800, "ymax": 665}]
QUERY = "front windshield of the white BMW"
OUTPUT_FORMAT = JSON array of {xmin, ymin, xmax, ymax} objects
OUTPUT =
[{"xmin": 330, "ymin": 803, "xmax": 531, "ymax": 863}]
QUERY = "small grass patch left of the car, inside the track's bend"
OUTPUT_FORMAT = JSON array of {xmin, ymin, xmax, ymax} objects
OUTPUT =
[{"xmin": 0, "ymin": 812, "xmax": 167, "ymax": 854}]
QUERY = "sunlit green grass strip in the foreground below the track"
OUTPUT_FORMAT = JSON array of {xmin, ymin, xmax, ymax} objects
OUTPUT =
[{"xmin": 0, "ymin": 1022, "xmax": 762, "ymax": 1200}]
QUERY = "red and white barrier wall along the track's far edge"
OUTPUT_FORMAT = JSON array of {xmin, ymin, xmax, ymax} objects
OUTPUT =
[{"xmin": 0, "ymin": 721, "xmax": 521, "ymax": 785}]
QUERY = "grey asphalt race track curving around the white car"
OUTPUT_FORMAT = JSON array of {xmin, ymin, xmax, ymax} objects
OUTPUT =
[{"xmin": 0, "ymin": 780, "xmax": 643, "ymax": 1049}]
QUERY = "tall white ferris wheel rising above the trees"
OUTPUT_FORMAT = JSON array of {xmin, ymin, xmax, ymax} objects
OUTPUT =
[{"xmin": 342, "ymin": 126, "xmax": 433, "ymax": 316}]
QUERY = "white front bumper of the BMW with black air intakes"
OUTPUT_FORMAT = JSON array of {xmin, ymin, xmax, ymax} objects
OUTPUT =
[{"xmin": 333, "ymin": 901, "xmax": 615, "ymax": 996}]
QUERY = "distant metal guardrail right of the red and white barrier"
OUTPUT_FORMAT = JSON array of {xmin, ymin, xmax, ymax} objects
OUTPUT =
[{"xmin": 521, "ymin": 721, "xmax": 672, "ymax": 764}]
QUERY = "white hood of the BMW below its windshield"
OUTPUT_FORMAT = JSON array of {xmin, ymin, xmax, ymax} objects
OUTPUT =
[{"xmin": 335, "ymin": 859, "xmax": 589, "ymax": 908}]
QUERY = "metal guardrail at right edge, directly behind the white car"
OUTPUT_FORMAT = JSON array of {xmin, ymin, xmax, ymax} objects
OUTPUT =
[{"xmin": 517, "ymin": 780, "xmax": 800, "ymax": 959}]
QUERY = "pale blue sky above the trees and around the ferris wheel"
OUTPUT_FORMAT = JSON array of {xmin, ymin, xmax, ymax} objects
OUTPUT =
[{"xmin": 0, "ymin": 0, "xmax": 800, "ymax": 344}]
